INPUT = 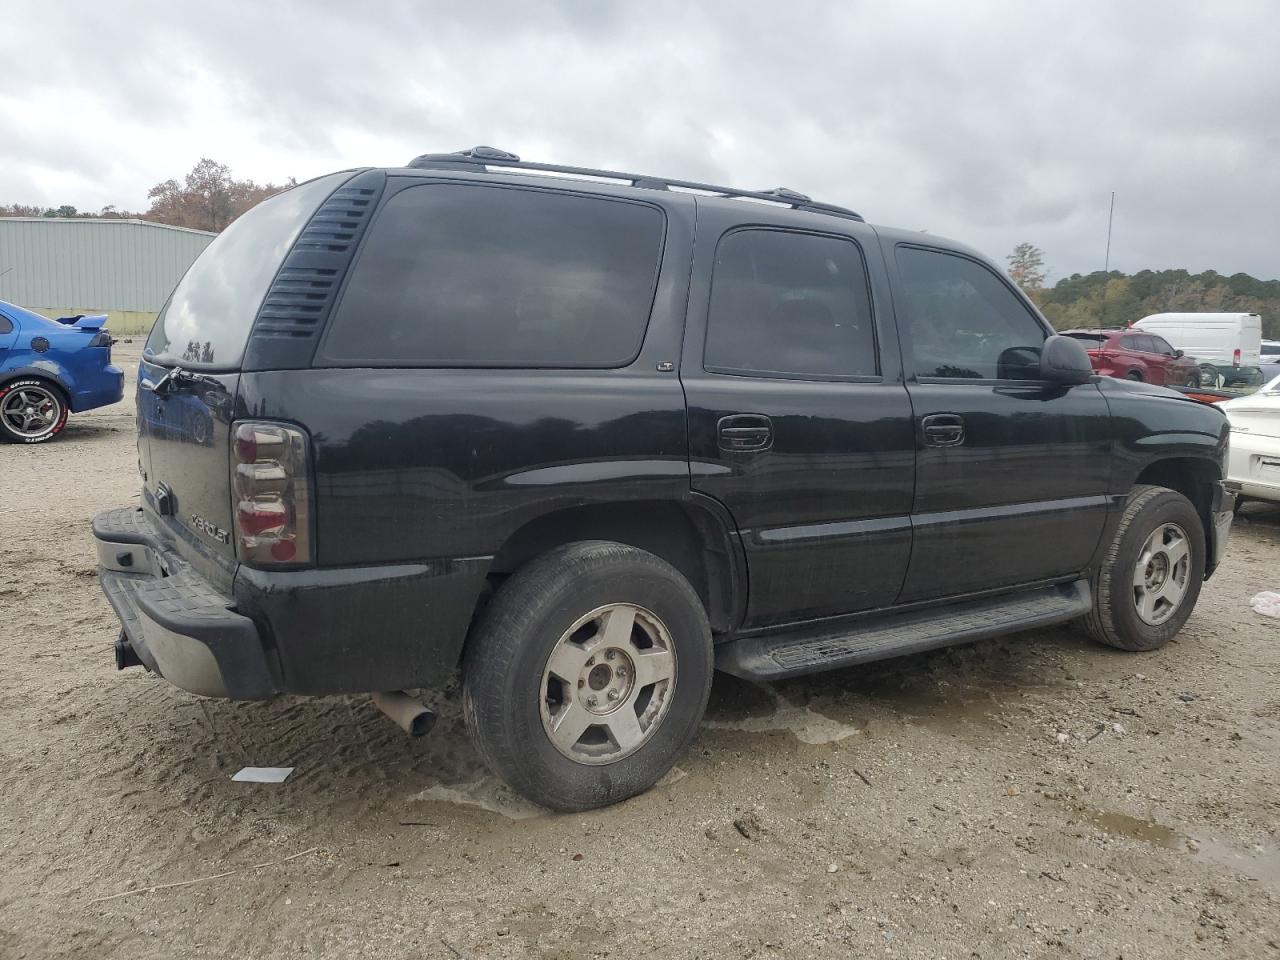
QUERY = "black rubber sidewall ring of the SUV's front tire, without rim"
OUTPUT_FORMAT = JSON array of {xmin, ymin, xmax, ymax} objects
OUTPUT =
[{"xmin": 1107, "ymin": 490, "xmax": 1206, "ymax": 650}]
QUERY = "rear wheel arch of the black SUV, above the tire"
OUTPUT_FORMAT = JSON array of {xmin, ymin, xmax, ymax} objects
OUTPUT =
[{"xmin": 481, "ymin": 498, "xmax": 746, "ymax": 634}]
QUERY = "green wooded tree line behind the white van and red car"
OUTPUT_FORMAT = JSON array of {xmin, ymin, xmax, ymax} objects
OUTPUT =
[{"xmin": 1006, "ymin": 243, "xmax": 1280, "ymax": 339}]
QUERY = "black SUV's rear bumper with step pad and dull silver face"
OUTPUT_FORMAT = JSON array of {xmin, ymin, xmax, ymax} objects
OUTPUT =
[{"xmin": 93, "ymin": 508, "xmax": 280, "ymax": 700}]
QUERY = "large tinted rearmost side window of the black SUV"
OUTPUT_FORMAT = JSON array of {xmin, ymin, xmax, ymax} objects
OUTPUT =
[{"xmin": 324, "ymin": 184, "xmax": 666, "ymax": 367}]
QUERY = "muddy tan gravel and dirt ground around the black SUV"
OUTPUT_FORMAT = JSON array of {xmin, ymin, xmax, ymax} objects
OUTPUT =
[{"xmin": 0, "ymin": 344, "xmax": 1280, "ymax": 960}]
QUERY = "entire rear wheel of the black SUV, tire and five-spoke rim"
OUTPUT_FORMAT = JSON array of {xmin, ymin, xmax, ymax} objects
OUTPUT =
[{"xmin": 462, "ymin": 540, "xmax": 713, "ymax": 812}]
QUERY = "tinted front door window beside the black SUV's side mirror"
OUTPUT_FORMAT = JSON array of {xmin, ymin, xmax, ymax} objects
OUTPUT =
[{"xmin": 897, "ymin": 247, "xmax": 1044, "ymax": 380}]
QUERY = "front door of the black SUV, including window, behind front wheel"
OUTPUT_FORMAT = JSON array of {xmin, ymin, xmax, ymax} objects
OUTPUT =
[{"xmin": 884, "ymin": 243, "xmax": 1111, "ymax": 603}]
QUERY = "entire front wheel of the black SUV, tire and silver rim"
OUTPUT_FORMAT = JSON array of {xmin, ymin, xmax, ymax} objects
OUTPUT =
[{"xmin": 1084, "ymin": 485, "xmax": 1204, "ymax": 650}]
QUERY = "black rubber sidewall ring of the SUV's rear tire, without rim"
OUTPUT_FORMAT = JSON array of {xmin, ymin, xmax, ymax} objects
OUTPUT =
[{"xmin": 468, "ymin": 547, "xmax": 713, "ymax": 810}]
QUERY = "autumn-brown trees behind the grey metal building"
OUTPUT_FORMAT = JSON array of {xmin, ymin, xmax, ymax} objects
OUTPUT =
[{"xmin": 0, "ymin": 157, "xmax": 296, "ymax": 233}]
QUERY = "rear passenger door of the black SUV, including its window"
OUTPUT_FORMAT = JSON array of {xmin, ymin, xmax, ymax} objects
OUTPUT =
[{"xmin": 681, "ymin": 213, "xmax": 915, "ymax": 626}]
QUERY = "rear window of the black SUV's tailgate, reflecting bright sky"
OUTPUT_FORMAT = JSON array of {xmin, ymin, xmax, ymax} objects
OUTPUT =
[{"xmin": 146, "ymin": 172, "xmax": 351, "ymax": 367}]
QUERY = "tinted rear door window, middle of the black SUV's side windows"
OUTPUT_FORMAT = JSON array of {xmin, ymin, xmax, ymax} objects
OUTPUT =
[{"xmin": 704, "ymin": 229, "xmax": 878, "ymax": 380}]
